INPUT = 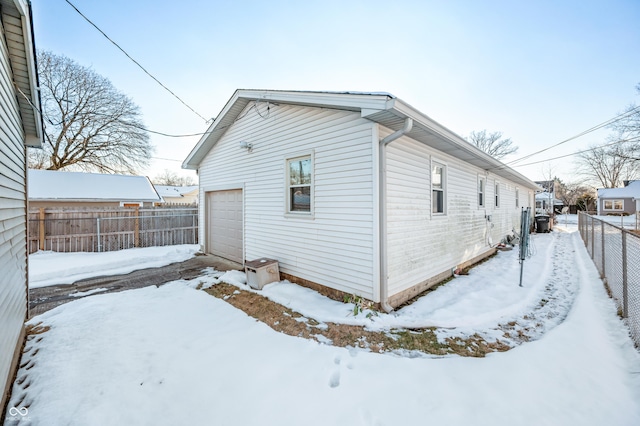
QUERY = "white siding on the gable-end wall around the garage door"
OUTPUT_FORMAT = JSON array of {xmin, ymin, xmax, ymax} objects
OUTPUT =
[{"xmin": 199, "ymin": 102, "xmax": 378, "ymax": 299}]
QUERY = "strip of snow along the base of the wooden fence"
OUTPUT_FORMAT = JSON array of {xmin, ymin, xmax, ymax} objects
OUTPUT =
[{"xmin": 29, "ymin": 244, "xmax": 200, "ymax": 288}]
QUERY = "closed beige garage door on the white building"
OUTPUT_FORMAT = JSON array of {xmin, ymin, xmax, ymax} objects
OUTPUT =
[{"xmin": 205, "ymin": 189, "xmax": 244, "ymax": 263}]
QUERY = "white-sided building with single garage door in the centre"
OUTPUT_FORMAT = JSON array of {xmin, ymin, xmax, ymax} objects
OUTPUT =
[{"xmin": 183, "ymin": 90, "xmax": 538, "ymax": 310}]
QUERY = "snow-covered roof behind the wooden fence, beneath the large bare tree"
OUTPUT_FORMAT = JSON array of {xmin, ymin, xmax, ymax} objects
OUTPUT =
[{"xmin": 28, "ymin": 170, "xmax": 162, "ymax": 201}]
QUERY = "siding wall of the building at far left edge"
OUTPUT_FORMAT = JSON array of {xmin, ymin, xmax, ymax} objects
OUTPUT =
[{"xmin": 0, "ymin": 11, "xmax": 27, "ymax": 400}]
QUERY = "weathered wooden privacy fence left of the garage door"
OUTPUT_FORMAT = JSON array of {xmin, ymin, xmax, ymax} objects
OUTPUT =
[{"xmin": 28, "ymin": 207, "xmax": 198, "ymax": 253}]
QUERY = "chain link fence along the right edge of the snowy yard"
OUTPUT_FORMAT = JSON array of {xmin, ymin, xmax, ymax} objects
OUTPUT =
[{"xmin": 578, "ymin": 212, "xmax": 640, "ymax": 348}]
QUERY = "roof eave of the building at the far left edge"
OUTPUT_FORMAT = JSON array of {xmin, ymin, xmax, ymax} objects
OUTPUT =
[{"xmin": 0, "ymin": 0, "xmax": 43, "ymax": 147}]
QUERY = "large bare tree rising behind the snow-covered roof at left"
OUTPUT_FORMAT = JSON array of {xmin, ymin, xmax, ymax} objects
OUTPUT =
[{"xmin": 29, "ymin": 51, "xmax": 153, "ymax": 174}]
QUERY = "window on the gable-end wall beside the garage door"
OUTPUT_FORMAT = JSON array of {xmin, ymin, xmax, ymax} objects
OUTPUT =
[{"xmin": 287, "ymin": 155, "xmax": 313, "ymax": 213}]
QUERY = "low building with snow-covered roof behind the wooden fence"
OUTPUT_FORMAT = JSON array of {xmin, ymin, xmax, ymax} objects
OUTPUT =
[{"xmin": 29, "ymin": 169, "xmax": 162, "ymax": 208}]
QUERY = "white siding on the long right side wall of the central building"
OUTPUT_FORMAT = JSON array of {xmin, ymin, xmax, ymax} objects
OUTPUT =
[{"xmin": 380, "ymin": 128, "xmax": 519, "ymax": 296}]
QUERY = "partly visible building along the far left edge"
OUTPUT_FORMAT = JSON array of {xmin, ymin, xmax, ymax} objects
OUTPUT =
[{"xmin": 0, "ymin": 0, "xmax": 42, "ymax": 412}]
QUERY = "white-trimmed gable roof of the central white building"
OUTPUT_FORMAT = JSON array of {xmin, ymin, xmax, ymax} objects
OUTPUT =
[{"xmin": 182, "ymin": 89, "xmax": 539, "ymax": 189}]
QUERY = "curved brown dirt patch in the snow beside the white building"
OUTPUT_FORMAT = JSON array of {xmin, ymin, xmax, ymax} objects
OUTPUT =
[{"xmin": 205, "ymin": 283, "xmax": 510, "ymax": 357}]
